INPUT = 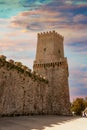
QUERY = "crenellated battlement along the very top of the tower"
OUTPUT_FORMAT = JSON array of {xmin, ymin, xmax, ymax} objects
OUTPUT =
[{"xmin": 38, "ymin": 30, "xmax": 64, "ymax": 39}]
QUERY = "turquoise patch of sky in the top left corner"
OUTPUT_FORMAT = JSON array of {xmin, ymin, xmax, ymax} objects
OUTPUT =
[{"xmin": 0, "ymin": 0, "xmax": 52, "ymax": 18}]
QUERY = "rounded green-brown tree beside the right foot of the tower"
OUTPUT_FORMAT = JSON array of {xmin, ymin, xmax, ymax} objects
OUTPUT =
[{"xmin": 71, "ymin": 98, "xmax": 86, "ymax": 115}]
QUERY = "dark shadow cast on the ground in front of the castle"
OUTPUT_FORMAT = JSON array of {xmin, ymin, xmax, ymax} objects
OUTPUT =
[{"xmin": 0, "ymin": 116, "xmax": 78, "ymax": 130}]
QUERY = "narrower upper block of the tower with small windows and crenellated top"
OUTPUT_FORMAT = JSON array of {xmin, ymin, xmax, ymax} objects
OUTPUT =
[{"xmin": 36, "ymin": 31, "xmax": 64, "ymax": 62}]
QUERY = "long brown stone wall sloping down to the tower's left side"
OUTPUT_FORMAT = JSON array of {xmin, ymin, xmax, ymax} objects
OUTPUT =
[{"xmin": 0, "ymin": 59, "xmax": 48, "ymax": 115}]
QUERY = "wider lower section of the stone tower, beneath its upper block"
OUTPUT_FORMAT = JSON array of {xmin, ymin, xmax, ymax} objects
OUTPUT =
[{"xmin": 34, "ymin": 59, "xmax": 70, "ymax": 115}]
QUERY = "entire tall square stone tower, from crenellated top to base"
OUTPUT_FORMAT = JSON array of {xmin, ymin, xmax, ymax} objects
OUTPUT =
[{"xmin": 33, "ymin": 31, "xmax": 70, "ymax": 115}]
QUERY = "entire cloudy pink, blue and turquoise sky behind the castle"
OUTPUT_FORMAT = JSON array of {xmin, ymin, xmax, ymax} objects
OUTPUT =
[{"xmin": 0, "ymin": 0, "xmax": 87, "ymax": 101}]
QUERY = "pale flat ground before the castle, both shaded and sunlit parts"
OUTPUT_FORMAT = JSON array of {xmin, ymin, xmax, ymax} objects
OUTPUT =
[{"xmin": 0, "ymin": 116, "xmax": 87, "ymax": 130}]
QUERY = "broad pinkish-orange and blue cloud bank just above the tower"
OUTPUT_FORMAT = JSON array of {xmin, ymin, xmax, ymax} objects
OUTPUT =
[{"xmin": 11, "ymin": 0, "xmax": 87, "ymax": 31}]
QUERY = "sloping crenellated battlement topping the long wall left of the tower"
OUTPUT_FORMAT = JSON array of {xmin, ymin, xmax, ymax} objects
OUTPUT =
[{"xmin": 0, "ymin": 55, "xmax": 48, "ymax": 83}]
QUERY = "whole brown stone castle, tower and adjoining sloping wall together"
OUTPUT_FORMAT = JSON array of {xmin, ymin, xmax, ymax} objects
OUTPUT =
[{"xmin": 0, "ymin": 31, "xmax": 70, "ymax": 115}]
